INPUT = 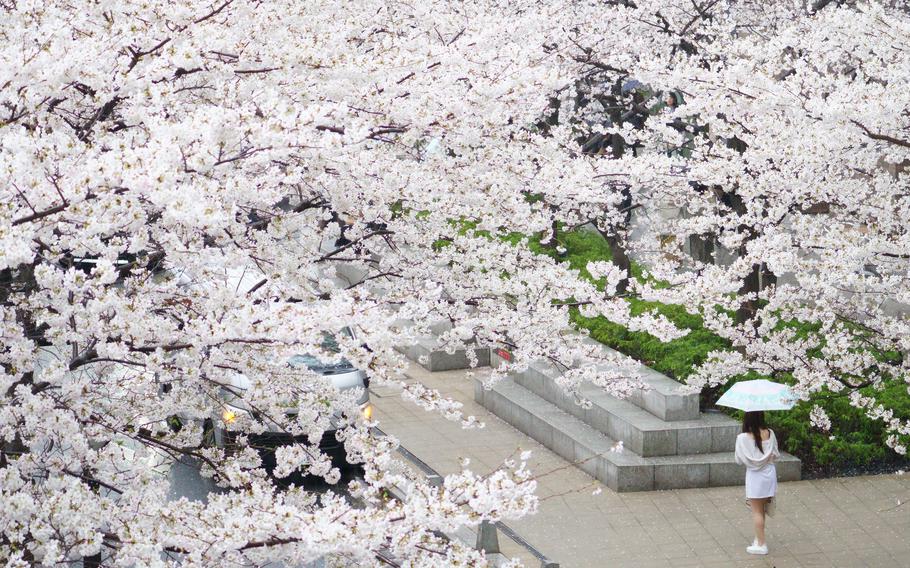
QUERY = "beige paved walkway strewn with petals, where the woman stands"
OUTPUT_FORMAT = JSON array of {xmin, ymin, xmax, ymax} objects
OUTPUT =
[{"xmin": 373, "ymin": 365, "xmax": 910, "ymax": 568}]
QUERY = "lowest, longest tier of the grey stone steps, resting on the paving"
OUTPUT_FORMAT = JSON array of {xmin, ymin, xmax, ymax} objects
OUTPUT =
[{"xmin": 474, "ymin": 379, "xmax": 800, "ymax": 491}]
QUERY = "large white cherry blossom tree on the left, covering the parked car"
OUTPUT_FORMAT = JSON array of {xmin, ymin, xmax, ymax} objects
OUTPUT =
[{"xmin": 0, "ymin": 0, "xmax": 679, "ymax": 566}]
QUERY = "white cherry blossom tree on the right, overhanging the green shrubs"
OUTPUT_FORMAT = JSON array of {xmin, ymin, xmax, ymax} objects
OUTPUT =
[{"xmin": 573, "ymin": 1, "xmax": 910, "ymax": 454}]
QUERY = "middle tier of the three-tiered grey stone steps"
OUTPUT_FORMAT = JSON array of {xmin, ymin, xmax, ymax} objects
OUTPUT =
[{"xmin": 510, "ymin": 361, "xmax": 741, "ymax": 457}]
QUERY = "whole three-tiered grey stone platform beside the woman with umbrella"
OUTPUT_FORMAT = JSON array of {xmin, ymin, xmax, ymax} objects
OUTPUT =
[{"xmin": 474, "ymin": 348, "xmax": 800, "ymax": 491}]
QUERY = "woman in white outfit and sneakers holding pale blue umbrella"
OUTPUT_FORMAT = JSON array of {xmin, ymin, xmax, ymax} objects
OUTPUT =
[{"xmin": 717, "ymin": 379, "xmax": 796, "ymax": 554}]
